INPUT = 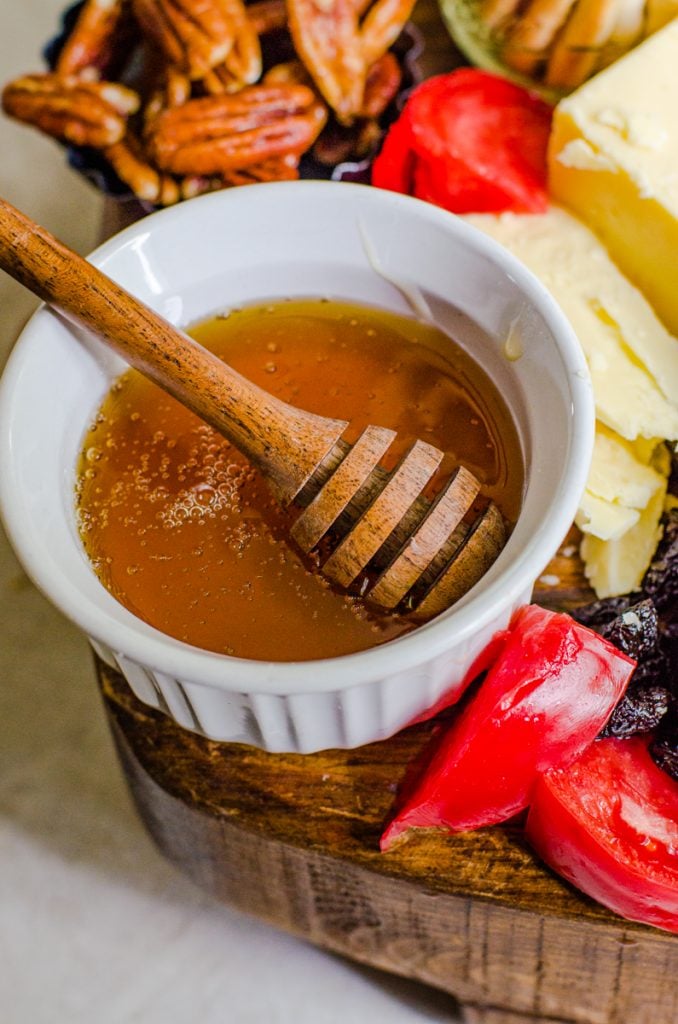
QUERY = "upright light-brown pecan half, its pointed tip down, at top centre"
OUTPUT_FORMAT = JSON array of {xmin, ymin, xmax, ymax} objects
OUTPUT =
[{"xmin": 287, "ymin": 0, "xmax": 368, "ymax": 123}]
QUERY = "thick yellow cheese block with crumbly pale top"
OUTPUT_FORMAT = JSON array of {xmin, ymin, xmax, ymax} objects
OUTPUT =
[{"xmin": 549, "ymin": 18, "xmax": 678, "ymax": 335}]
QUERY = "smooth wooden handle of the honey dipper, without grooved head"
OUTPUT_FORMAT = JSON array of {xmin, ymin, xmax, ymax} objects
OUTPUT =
[{"xmin": 0, "ymin": 199, "xmax": 346, "ymax": 503}]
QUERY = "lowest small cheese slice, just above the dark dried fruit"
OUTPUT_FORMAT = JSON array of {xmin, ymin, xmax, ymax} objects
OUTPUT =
[{"xmin": 582, "ymin": 482, "xmax": 666, "ymax": 597}]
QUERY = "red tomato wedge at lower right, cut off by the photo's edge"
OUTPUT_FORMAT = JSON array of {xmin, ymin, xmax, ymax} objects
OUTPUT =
[{"xmin": 526, "ymin": 736, "xmax": 678, "ymax": 932}]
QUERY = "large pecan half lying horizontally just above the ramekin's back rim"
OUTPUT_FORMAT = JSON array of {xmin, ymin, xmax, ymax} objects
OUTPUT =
[{"xmin": 146, "ymin": 85, "xmax": 325, "ymax": 176}]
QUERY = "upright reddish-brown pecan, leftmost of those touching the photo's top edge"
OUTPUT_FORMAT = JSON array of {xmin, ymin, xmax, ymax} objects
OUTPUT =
[{"xmin": 54, "ymin": 0, "xmax": 137, "ymax": 78}]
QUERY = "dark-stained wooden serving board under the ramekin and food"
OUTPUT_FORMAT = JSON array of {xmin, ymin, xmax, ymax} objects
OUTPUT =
[{"xmin": 96, "ymin": 0, "xmax": 678, "ymax": 1024}]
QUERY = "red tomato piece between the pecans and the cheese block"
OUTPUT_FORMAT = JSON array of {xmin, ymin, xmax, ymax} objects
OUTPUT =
[{"xmin": 372, "ymin": 68, "xmax": 552, "ymax": 213}]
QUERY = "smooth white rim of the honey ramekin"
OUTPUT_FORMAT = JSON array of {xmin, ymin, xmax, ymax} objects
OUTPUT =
[{"xmin": 0, "ymin": 181, "xmax": 595, "ymax": 695}]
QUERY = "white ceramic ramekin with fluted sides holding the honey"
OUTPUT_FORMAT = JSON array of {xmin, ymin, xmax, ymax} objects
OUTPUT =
[{"xmin": 0, "ymin": 181, "xmax": 594, "ymax": 753}]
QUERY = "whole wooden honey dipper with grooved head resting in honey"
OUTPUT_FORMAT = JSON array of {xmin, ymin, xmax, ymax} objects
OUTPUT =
[{"xmin": 0, "ymin": 200, "xmax": 506, "ymax": 620}]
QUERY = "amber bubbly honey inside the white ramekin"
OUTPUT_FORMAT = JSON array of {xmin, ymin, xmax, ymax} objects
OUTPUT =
[{"xmin": 77, "ymin": 299, "xmax": 523, "ymax": 662}]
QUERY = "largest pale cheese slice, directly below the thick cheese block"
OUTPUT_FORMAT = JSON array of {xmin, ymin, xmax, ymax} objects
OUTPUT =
[{"xmin": 465, "ymin": 206, "xmax": 678, "ymax": 440}]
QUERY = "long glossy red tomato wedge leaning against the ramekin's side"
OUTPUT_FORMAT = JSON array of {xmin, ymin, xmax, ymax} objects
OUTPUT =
[{"xmin": 381, "ymin": 605, "xmax": 635, "ymax": 849}]
